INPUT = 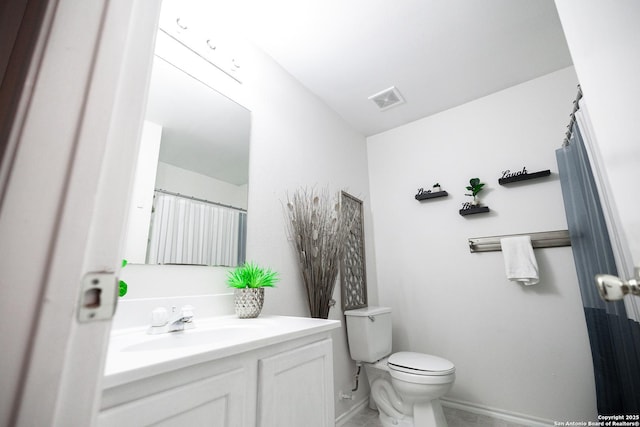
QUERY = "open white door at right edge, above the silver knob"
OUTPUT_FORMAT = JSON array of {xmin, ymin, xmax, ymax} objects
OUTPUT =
[{"xmin": 556, "ymin": 0, "xmax": 640, "ymax": 276}]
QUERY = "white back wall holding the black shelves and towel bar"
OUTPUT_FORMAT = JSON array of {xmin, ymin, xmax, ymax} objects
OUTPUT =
[{"xmin": 368, "ymin": 68, "xmax": 596, "ymax": 420}]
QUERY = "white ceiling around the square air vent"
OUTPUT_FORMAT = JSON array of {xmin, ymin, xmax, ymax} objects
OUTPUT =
[{"xmin": 194, "ymin": 0, "xmax": 571, "ymax": 136}]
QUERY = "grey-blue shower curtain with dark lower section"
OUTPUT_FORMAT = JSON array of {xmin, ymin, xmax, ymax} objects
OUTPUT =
[{"xmin": 556, "ymin": 124, "xmax": 640, "ymax": 414}]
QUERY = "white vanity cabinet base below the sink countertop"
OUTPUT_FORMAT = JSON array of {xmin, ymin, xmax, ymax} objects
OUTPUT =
[{"xmin": 97, "ymin": 318, "xmax": 335, "ymax": 427}]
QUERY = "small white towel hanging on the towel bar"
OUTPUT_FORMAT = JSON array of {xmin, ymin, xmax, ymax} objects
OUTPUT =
[{"xmin": 500, "ymin": 236, "xmax": 539, "ymax": 285}]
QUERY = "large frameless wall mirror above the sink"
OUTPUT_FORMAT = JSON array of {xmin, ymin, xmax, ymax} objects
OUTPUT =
[{"xmin": 125, "ymin": 55, "xmax": 251, "ymax": 266}]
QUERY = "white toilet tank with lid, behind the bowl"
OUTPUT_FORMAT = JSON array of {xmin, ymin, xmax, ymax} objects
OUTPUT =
[{"xmin": 344, "ymin": 307, "xmax": 391, "ymax": 363}]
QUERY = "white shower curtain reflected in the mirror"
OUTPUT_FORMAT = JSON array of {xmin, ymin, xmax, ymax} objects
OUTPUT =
[{"xmin": 147, "ymin": 193, "xmax": 247, "ymax": 267}]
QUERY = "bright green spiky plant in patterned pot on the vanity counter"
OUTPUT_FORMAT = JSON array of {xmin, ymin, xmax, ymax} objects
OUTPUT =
[{"xmin": 227, "ymin": 262, "xmax": 279, "ymax": 319}]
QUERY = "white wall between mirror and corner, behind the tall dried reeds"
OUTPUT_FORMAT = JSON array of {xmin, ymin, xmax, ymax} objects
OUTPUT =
[{"xmin": 245, "ymin": 45, "xmax": 377, "ymax": 416}]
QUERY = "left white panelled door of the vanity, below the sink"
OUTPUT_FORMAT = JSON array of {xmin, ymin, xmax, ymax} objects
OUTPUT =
[{"xmin": 98, "ymin": 368, "xmax": 247, "ymax": 427}]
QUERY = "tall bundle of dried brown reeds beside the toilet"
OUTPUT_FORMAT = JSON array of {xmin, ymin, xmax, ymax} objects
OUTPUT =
[{"xmin": 286, "ymin": 188, "xmax": 353, "ymax": 319}]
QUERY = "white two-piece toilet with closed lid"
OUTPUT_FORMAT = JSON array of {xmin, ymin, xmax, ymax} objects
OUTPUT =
[{"xmin": 344, "ymin": 307, "xmax": 456, "ymax": 427}]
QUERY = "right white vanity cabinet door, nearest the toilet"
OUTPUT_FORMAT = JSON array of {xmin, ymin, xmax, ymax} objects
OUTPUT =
[{"xmin": 257, "ymin": 339, "xmax": 335, "ymax": 427}]
